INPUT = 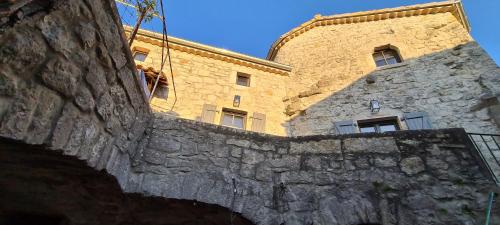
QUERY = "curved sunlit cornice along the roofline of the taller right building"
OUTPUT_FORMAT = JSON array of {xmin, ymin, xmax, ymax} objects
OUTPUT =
[{"xmin": 266, "ymin": 0, "xmax": 470, "ymax": 60}]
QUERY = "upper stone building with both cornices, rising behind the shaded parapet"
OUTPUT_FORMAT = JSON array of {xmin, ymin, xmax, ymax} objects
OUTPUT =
[{"xmin": 127, "ymin": 1, "xmax": 500, "ymax": 136}]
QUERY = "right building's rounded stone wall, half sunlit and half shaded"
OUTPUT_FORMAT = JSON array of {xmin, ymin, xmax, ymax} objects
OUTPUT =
[{"xmin": 275, "ymin": 13, "xmax": 500, "ymax": 135}]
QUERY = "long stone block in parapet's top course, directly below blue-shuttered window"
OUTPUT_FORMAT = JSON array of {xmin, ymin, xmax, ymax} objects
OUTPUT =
[{"xmin": 344, "ymin": 137, "xmax": 399, "ymax": 154}]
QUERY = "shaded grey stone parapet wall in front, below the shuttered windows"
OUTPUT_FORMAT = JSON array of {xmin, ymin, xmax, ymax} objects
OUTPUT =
[{"xmin": 131, "ymin": 114, "xmax": 498, "ymax": 225}]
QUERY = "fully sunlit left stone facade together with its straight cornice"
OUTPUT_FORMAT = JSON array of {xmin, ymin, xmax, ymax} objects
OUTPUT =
[{"xmin": 132, "ymin": 31, "xmax": 290, "ymax": 135}]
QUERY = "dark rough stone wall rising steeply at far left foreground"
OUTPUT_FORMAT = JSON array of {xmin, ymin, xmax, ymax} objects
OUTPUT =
[{"xmin": 0, "ymin": 0, "xmax": 150, "ymax": 186}]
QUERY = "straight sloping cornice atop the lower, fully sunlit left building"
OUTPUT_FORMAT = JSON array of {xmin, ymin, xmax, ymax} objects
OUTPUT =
[{"xmin": 124, "ymin": 26, "xmax": 292, "ymax": 76}]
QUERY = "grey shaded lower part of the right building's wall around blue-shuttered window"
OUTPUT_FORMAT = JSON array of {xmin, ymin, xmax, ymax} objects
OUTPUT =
[{"xmin": 284, "ymin": 42, "xmax": 500, "ymax": 136}]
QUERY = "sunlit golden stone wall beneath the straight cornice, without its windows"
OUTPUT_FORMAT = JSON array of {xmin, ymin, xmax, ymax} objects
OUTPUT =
[{"xmin": 133, "ymin": 40, "xmax": 288, "ymax": 135}]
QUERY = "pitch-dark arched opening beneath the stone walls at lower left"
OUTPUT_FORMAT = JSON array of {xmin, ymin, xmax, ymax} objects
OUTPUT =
[{"xmin": 0, "ymin": 137, "xmax": 252, "ymax": 225}]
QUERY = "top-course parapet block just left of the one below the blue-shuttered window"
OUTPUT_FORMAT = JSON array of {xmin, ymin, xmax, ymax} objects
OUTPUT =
[{"xmin": 290, "ymin": 139, "xmax": 342, "ymax": 155}]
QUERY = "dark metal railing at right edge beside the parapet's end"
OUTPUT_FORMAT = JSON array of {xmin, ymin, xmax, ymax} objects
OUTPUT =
[{"xmin": 468, "ymin": 133, "xmax": 500, "ymax": 184}]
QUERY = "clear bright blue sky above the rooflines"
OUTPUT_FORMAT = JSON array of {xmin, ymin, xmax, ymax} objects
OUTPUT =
[{"xmin": 119, "ymin": 0, "xmax": 500, "ymax": 64}]
